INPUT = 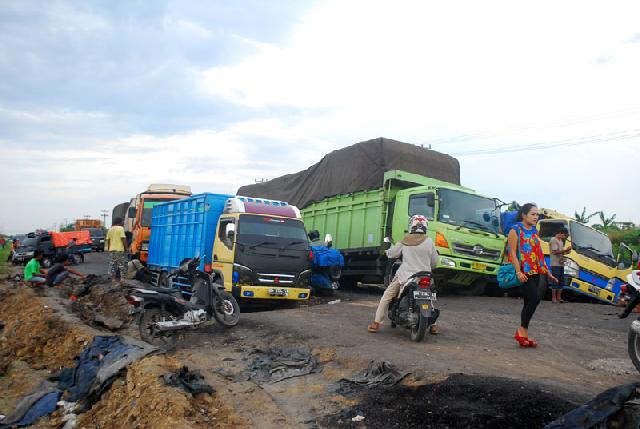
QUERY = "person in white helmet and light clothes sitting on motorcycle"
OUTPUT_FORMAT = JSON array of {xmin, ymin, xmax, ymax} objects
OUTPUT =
[{"xmin": 367, "ymin": 214, "xmax": 440, "ymax": 334}]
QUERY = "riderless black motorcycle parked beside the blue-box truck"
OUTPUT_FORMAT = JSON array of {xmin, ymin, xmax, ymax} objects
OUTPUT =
[{"xmin": 127, "ymin": 258, "xmax": 240, "ymax": 349}]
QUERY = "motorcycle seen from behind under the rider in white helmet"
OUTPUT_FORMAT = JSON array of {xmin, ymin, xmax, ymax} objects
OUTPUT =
[{"xmin": 389, "ymin": 271, "xmax": 440, "ymax": 342}]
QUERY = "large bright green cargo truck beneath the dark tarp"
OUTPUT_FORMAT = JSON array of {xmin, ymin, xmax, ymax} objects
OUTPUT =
[{"xmin": 302, "ymin": 170, "xmax": 506, "ymax": 294}]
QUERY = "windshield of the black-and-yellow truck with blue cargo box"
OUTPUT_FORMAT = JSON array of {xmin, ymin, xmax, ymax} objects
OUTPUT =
[{"xmin": 238, "ymin": 215, "xmax": 308, "ymax": 245}]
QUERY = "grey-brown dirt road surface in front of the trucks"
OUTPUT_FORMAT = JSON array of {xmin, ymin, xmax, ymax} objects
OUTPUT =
[{"xmin": 67, "ymin": 254, "xmax": 640, "ymax": 428}]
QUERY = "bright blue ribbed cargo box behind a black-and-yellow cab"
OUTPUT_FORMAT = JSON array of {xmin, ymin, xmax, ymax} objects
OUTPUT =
[{"xmin": 147, "ymin": 193, "xmax": 233, "ymax": 273}]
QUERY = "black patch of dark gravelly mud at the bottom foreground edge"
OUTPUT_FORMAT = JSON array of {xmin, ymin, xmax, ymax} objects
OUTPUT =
[{"xmin": 319, "ymin": 374, "xmax": 577, "ymax": 429}]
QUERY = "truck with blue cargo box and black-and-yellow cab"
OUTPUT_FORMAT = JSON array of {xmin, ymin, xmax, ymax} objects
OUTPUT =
[{"xmin": 147, "ymin": 193, "xmax": 313, "ymax": 301}]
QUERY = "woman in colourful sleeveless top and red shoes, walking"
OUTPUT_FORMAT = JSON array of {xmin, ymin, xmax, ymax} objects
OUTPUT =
[{"xmin": 508, "ymin": 203, "xmax": 558, "ymax": 347}]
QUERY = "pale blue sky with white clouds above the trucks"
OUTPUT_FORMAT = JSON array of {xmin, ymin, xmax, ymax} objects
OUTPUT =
[{"xmin": 0, "ymin": 0, "xmax": 640, "ymax": 233}]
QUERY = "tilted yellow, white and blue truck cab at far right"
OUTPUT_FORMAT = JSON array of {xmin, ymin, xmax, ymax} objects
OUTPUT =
[{"xmin": 538, "ymin": 209, "xmax": 631, "ymax": 304}]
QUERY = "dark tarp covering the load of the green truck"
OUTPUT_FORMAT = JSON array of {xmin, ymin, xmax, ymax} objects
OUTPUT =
[{"xmin": 237, "ymin": 137, "xmax": 460, "ymax": 208}]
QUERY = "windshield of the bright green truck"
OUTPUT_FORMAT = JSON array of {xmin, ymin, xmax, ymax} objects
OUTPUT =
[{"xmin": 438, "ymin": 189, "xmax": 500, "ymax": 234}]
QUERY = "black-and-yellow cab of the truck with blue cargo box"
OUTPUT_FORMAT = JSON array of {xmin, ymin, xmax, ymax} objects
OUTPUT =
[{"xmin": 212, "ymin": 197, "xmax": 313, "ymax": 300}]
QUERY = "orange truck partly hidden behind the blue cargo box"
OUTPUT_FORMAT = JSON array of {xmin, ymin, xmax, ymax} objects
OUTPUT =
[{"xmin": 125, "ymin": 184, "xmax": 191, "ymax": 263}]
